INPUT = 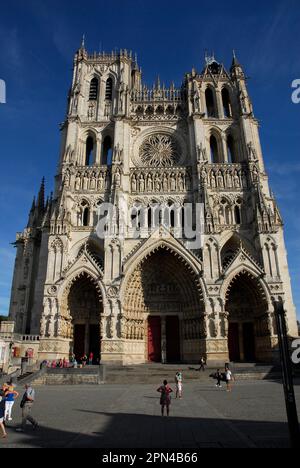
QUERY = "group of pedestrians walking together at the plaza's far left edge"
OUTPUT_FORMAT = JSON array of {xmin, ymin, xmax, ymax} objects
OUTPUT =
[{"xmin": 0, "ymin": 381, "xmax": 38, "ymax": 438}]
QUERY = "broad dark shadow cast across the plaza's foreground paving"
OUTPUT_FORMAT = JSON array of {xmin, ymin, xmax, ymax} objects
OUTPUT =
[{"xmin": 0, "ymin": 408, "xmax": 289, "ymax": 449}]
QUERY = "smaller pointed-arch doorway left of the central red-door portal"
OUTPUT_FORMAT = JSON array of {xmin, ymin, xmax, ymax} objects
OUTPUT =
[{"xmin": 68, "ymin": 272, "xmax": 103, "ymax": 364}]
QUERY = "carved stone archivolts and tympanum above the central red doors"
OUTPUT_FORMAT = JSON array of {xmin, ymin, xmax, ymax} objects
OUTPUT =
[{"xmin": 122, "ymin": 246, "xmax": 204, "ymax": 339}]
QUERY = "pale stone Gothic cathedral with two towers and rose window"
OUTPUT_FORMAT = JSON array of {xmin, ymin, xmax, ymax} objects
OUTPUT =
[{"xmin": 1, "ymin": 42, "xmax": 298, "ymax": 365}]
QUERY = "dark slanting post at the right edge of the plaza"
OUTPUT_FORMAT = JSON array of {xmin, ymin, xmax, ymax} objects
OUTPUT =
[{"xmin": 273, "ymin": 301, "xmax": 300, "ymax": 448}]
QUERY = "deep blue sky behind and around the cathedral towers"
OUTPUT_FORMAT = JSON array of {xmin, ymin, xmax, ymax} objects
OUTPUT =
[{"xmin": 0, "ymin": 0, "xmax": 300, "ymax": 316}]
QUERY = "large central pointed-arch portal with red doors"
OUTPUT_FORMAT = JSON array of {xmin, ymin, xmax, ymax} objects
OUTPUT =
[{"xmin": 124, "ymin": 246, "xmax": 203, "ymax": 363}]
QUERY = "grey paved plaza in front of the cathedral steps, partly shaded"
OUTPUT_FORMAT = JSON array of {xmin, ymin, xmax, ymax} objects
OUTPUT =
[{"xmin": 0, "ymin": 380, "xmax": 300, "ymax": 448}]
